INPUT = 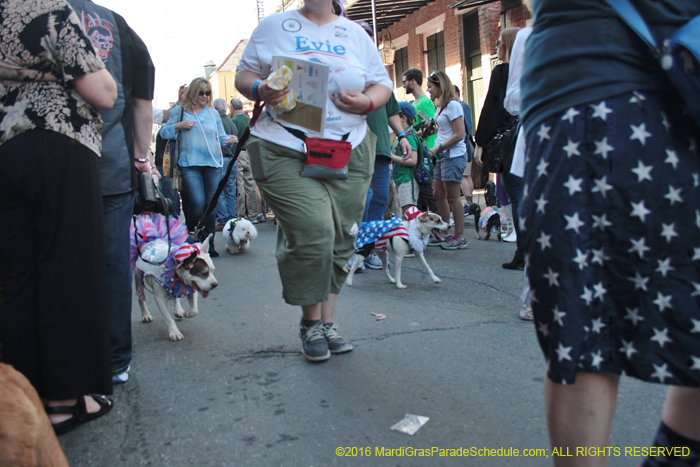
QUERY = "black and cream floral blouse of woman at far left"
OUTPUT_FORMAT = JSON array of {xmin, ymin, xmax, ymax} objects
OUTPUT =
[{"xmin": 0, "ymin": 0, "xmax": 104, "ymax": 155}]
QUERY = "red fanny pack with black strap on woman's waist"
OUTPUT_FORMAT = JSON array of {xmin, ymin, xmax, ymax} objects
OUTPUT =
[{"xmin": 281, "ymin": 125, "xmax": 352, "ymax": 180}]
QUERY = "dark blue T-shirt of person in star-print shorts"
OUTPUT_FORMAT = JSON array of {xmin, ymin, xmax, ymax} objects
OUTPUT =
[{"xmin": 521, "ymin": 0, "xmax": 700, "ymax": 131}]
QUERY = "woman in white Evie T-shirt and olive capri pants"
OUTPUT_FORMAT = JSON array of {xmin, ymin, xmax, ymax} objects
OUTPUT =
[{"xmin": 236, "ymin": 0, "xmax": 393, "ymax": 361}]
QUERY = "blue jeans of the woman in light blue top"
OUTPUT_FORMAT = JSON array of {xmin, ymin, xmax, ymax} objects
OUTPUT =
[{"xmin": 180, "ymin": 166, "xmax": 221, "ymax": 248}]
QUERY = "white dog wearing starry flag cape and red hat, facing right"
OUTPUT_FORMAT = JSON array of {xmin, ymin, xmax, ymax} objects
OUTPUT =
[{"xmin": 345, "ymin": 207, "xmax": 448, "ymax": 289}]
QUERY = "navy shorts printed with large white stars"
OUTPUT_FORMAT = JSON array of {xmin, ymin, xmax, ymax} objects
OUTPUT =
[{"xmin": 520, "ymin": 92, "xmax": 700, "ymax": 386}]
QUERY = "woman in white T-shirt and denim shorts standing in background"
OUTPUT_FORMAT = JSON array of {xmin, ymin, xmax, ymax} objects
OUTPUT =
[{"xmin": 428, "ymin": 71, "xmax": 467, "ymax": 250}]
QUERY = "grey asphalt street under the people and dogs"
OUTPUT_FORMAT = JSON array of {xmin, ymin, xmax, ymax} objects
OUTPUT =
[{"xmin": 60, "ymin": 214, "xmax": 665, "ymax": 467}]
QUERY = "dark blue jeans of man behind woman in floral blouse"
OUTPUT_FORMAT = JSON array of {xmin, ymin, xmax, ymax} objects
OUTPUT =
[{"xmin": 102, "ymin": 191, "xmax": 136, "ymax": 375}]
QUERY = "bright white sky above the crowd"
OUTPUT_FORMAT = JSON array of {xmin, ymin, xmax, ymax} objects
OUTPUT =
[{"xmin": 94, "ymin": 0, "xmax": 288, "ymax": 108}]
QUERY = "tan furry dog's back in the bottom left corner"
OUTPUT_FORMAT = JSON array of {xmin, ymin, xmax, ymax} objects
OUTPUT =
[{"xmin": 0, "ymin": 363, "xmax": 68, "ymax": 467}]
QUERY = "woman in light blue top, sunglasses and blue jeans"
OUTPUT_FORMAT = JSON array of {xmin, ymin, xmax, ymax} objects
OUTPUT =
[{"xmin": 160, "ymin": 78, "xmax": 236, "ymax": 257}]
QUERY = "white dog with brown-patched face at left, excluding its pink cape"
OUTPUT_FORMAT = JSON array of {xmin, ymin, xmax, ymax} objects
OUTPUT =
[{"xmin": 134, "ymin": 234, "xmax": 219, "ymax": 341}]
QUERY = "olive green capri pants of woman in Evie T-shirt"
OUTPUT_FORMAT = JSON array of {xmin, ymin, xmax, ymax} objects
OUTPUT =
[{"xmin": 246, "ymin": 129, "xmax": 376, "ymax": 306}]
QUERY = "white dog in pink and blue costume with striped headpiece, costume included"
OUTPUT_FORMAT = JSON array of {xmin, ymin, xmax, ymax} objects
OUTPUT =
[{"xmin": 131, "ymin": 213, "xmax": 219, "ymax": 341}]
